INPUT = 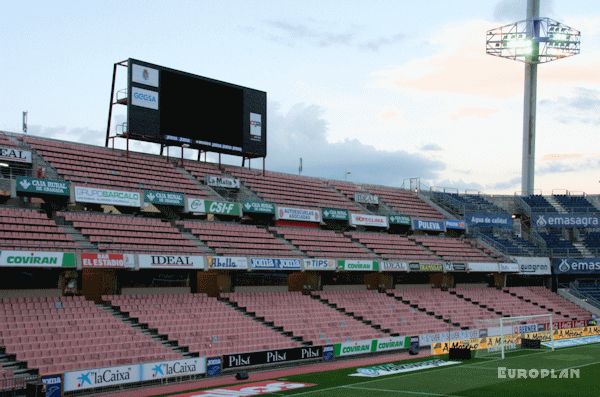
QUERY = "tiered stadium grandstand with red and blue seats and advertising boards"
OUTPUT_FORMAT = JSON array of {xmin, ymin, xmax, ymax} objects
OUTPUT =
[{"xmin": 0, "ymin": 129, "xmax": 600, "ymax": 394}]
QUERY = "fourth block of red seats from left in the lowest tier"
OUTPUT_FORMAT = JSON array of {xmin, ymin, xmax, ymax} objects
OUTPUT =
[{"xmin": 314, "ymin": 290, "xmax": 448, "ymax": 335}]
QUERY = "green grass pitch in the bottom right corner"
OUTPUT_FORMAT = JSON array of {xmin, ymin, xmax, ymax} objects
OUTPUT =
[{"xmin": 268, "ymin": 344, "xmax": 600, "ymax": 397}]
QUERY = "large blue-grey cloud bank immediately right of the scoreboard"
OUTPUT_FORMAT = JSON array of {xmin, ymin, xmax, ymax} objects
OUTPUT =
[{"xmin": 267, "ymin": 104, "xmax": 445, "ymax": 186}]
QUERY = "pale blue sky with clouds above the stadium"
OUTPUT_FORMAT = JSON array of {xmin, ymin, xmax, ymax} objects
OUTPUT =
[{"xmin": 0, "ymin": 0, "xmax": 600, "ymax": 194}]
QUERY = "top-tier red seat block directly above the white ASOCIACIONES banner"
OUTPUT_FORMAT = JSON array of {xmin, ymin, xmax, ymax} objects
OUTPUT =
[{"xmin": 226, "ymin": 167, "xmax": 360, "ymax": 212}]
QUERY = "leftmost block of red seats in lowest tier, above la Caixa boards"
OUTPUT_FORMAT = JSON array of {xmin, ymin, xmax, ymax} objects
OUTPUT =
[{"xmin": 0, "ymin": 296, "xmax": 182, "ymax": 374}]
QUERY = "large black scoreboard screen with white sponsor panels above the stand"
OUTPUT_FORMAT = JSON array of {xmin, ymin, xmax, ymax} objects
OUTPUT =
[{"xmin": 127, "ymin": 59, "xmax": 267, "ymax": 157}]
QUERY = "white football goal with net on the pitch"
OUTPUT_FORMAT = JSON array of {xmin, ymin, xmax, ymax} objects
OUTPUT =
[{"xmin": 475, "ymin": 313, "xmax": 554, "ymax": 359}]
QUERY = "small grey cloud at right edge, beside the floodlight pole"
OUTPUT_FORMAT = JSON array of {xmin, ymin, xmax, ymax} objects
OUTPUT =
[{"xmin": 540, "ymin": 87, "xmax": 600, "ymax": 124}]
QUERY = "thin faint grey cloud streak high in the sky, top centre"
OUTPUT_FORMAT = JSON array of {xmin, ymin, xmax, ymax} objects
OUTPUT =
[{"xmin": 244, "ymin": 19, "xmax": 405, "ymax": 52}]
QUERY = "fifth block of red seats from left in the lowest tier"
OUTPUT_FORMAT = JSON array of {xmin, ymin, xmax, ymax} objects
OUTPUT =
[{"xmin": 390, "ymin": 288, "xmax": 498, "ymax": 328}]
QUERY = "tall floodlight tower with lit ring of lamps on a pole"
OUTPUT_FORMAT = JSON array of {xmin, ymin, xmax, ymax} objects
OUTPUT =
[{"xmin": 485, "ymin": 0, "xmax": 581, "ymax": 195}]
